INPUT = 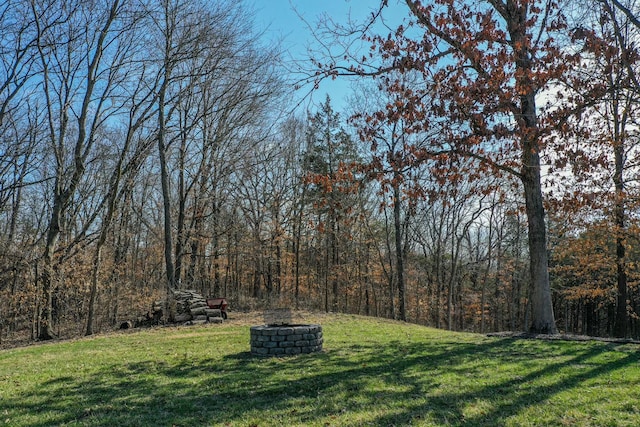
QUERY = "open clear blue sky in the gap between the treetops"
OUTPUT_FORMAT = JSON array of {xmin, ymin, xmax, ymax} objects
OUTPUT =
[{"xmin": 254, "ymin": 0, "xmax": 404, "ymax": 111}]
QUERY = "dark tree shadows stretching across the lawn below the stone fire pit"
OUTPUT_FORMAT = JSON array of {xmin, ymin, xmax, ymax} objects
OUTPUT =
[{"xmin": 0, "ymin": 339, "xmax": 640, "ymax": 426}]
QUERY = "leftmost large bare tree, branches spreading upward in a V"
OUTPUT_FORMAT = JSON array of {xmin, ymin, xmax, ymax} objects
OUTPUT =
[{"xmin": 29, "ymin": 0, "xmax": 140, "ymax": 339}]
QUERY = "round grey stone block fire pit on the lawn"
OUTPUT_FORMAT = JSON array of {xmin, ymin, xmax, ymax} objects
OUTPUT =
[{"xmin": 251, "ymin": 325, "xmax": 322, "ymax": 356}]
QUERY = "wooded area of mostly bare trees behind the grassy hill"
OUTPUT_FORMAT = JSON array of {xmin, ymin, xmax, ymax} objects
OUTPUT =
[{"xmin": 0, "ymin": 0, "xmax": 640, "ymax": 344}]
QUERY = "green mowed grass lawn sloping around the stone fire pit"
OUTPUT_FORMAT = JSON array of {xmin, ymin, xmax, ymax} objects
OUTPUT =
[{"xmin": 0, "ymin": 313, "xmax": 640, "ymax": 426}]
